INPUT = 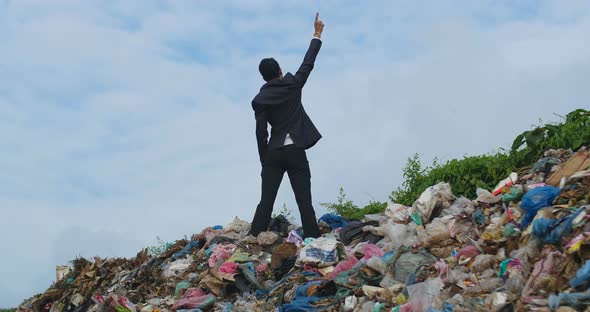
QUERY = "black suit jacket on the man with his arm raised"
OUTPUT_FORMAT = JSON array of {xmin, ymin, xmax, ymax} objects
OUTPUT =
[{"xmin": 252, "ymin": 38, "xmax": 322, "ymax": 162}]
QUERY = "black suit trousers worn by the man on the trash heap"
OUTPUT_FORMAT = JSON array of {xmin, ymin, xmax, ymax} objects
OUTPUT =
[{"xmin": 250, "ymin": 145, "xmax": 321, "ymax": 237}]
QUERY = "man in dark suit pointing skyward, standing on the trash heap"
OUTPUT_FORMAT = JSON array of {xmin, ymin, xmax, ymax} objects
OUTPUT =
[{"xmin": 250, "ymin": 13, "xmax": 324, "ymax": 237}]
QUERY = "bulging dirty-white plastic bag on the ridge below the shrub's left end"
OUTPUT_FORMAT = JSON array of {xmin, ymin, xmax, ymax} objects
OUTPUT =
[{"xmin": 412, "ymin": 182, "xmax": 455, "ymax": 223}]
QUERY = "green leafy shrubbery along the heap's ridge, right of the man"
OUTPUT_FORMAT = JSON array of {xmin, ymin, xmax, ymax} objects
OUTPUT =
[{"xmin": 322, "ymin": 109, "xmax": 590, "ymax": 218}]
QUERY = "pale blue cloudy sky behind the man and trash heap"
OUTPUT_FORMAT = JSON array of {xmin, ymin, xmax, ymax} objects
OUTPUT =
[{"xmin": 0, "ymin": 0, "xmax": 590, "ymax": 307}]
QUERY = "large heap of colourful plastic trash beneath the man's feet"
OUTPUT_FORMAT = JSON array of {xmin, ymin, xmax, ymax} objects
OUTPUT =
[{"xmin": 18, "ymin": 148, "xmax": 590, "ymax": 312}]
